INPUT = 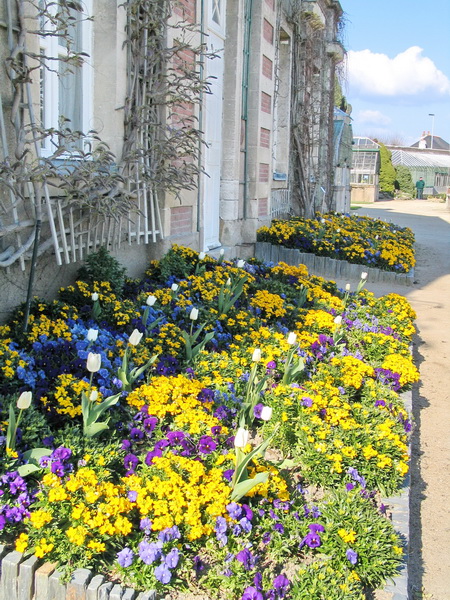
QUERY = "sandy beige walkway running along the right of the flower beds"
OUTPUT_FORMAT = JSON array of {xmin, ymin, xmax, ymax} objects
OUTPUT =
[{"xmin": 352, "ymin": 200, "xmax": 450, "ymax": 600}]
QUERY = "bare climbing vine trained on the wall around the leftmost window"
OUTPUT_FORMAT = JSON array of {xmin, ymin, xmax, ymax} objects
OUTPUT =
[{"xmin": 0, "ymin": 0, "xmax": 213, "ymax": 268}]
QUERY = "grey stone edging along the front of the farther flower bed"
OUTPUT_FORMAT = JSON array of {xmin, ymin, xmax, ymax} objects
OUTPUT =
[{"xmin": 255, "ymin": 242, "xmax": 414, "ymax": 286}]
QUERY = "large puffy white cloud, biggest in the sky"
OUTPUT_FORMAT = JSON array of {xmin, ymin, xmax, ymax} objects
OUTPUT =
[{"xmin": 347, "ymin": 46, "xmax": 450, "ymax": 100}]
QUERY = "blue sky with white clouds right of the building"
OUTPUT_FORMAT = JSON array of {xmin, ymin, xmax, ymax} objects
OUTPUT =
[{"xmin": 340, "ymin": 0, "xmax": 450, "ymax": 146}]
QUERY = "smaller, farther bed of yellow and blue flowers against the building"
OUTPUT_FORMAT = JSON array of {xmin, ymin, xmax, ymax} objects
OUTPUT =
[{"xmin": 257, "ymin": 213, "xmax": 415, "ymax": 273}]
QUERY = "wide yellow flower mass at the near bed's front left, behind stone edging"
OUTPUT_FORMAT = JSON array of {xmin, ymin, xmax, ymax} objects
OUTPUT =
[{"xmin": 21, "ymin": 454, "xmax": 231, "ymax": 556}]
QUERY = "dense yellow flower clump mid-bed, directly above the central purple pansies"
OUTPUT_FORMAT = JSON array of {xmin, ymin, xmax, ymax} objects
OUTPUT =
[{"xmin": 127, "ymin": 375, "xmax": 220, "ymax": 434}]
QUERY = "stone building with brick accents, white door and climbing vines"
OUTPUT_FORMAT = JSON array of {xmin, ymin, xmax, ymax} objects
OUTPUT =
[{"xmin": 0, "ymin": 0, "xmax": 349, "ymax": 317}]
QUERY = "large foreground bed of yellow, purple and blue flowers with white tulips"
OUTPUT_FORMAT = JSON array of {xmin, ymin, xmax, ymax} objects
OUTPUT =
[{"xmin": 0, "ymin": 247, "xmax": 418, "ymax": 600}]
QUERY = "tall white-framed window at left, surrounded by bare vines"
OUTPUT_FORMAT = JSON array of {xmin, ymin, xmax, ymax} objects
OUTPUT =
[{"xmin": 40, "ymin": 0, "xmax": 92, "ymax": 156}]
